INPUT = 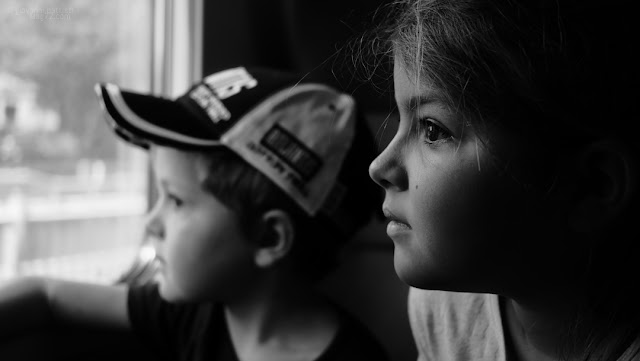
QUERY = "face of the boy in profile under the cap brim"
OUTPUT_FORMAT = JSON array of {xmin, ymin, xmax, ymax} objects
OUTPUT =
[{"xmin": 147, "ymin": 146, "xmax": 255, "ymax": 301}]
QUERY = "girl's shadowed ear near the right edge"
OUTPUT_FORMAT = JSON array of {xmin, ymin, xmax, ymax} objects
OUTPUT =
[{"xmin": 569, "ymin": 140, "xmax": 638, "ymax": 233}]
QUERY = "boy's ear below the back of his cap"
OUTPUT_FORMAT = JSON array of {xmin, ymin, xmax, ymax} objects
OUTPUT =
[{"xmin": 255, "ymin": 209, "xmax": 295, "ymax": 268}]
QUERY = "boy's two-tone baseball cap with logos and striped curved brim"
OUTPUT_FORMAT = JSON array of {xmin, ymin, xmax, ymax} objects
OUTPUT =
[{"xmin": 95, "ymin": 67, "xmax": 372, "ymax": 231}]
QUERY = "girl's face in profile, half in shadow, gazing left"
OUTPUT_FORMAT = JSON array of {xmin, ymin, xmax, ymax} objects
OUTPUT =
[{"xmin": 369, "ymin": 61, "xmax": 568, "ymax": 292}]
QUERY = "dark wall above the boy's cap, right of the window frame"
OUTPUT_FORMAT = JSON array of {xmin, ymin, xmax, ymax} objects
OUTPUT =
[{"xmin": 203, "ymin": 0, "xmax": 392, "ymax": 113}]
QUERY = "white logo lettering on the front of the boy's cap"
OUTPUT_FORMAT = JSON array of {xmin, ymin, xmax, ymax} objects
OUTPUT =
[{"xmin": 189, "ymin": 67, "xmax": 258, "ymax": 124}]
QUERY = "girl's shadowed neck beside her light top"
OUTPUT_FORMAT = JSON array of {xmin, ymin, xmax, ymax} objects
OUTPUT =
[{"xmin": 496, "ymin": 236, "xmax": 587, "ymax": 361}]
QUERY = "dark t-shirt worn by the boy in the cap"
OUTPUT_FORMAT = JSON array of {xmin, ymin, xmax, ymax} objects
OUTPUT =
[{"xmin": 128, "ymin": 284, "xmax": 388, "ymax": 361}]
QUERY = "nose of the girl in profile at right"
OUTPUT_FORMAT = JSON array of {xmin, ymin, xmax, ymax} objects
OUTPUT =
[{"xmin": 369, "ymin": 137, "xmax": 408, "ymax": 191}]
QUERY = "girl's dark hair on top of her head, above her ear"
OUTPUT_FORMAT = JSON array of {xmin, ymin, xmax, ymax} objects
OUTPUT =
[{"xmin": 375, "ymin": 0, "xmax": 638, "ymax": 143}]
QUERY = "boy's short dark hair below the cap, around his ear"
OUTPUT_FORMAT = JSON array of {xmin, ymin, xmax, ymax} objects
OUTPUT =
[{"xmin": 190, "ymin": 114, "xmax": 381, "ymax": 281}]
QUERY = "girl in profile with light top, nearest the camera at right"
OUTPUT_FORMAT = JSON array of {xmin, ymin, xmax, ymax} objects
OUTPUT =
[{"xmin": 370, "ymin": 0, "xmax": 640, "ymax": 361}]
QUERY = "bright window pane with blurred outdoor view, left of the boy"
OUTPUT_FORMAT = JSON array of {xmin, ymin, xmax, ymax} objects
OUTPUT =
[{"xmin": 0, "ymin": 0, "xmax": 153, "ymax": 283}]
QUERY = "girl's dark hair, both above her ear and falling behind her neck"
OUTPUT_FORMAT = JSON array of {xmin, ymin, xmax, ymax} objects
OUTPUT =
[{"xmin": 360, "ymin": 0, "xmax": 640, "ymax": 360}]
